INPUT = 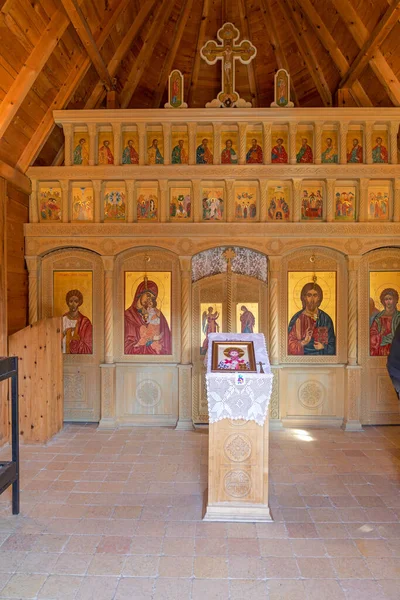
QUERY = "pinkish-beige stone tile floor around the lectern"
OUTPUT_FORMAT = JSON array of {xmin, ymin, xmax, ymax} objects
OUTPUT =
[{"xmin": 0, "ymin": 424, "xmax": 400, "ymax": 600}]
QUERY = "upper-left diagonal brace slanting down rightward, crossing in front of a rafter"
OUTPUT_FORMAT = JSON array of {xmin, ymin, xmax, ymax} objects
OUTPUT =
[{"xmin": 61, "ymin": 0, "xmax": 114, "ymax": 90}]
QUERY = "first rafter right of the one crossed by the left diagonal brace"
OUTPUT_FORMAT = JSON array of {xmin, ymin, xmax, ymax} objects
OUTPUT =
[{"xmin": 121, "ymin": 0, "xmax": 174, "ymax": 108}]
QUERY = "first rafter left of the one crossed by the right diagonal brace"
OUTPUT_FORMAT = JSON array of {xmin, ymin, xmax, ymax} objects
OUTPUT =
[{"xmin": 279, "ymin": 0, "xmax": 332, "ymax": 106}]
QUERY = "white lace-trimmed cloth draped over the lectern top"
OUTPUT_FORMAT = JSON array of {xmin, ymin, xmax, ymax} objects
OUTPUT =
[{"xmin": 206, "ymin": 333, "xmax": 273, "ymax": 426}]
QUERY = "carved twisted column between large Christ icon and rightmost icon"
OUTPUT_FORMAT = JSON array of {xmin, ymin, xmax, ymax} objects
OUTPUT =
[{"xmin": 343, "ymin": 256, "xmax": 362, "ymax": 431}]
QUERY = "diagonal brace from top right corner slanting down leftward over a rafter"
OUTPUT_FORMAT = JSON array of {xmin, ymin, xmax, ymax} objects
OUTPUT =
[{"xmin": 339, "ymin": 0, "xmax": 400, "ymax": 88}]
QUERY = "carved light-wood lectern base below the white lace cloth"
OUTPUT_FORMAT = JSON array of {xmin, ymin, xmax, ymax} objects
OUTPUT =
[{"xmin": 204, "ymin": 419, "xmax": 272, "ymax": 522}]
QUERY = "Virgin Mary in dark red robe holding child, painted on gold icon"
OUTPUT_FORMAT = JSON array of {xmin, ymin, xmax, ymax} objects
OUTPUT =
[{"xmin": 124, "ymin": 277, "xmax": 172, "ymax": 354}]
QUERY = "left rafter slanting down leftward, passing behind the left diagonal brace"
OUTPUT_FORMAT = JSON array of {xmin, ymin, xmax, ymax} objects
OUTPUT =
[{"xmin": 85, "ymin": 0, "xmax": 157, "ymax": 109}]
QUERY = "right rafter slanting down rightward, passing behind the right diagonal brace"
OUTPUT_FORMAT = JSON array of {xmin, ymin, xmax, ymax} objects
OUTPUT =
[{"xmin": 332, "ymin": 0, "xmax": 400, "ymax": 106}]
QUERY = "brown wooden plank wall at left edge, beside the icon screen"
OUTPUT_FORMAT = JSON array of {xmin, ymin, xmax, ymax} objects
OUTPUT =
[{"xmin": 0, "ymin": 177, "xmax": 29, "ymax": 446}]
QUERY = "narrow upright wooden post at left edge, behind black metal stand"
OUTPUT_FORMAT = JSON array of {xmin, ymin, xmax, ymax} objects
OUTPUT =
[{"xmin": 0, "ymin": 177, "xmax": 8, "ymax": 446}]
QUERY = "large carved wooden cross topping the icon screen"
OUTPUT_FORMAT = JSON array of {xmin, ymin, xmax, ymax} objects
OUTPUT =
[{"xmin": 200, "ymin": 23, "xmax": 257, "ymax": 106}]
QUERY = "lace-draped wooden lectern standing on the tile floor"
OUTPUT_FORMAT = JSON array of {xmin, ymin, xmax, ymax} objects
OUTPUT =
[{"xmin": 204, "ymin": 333, "xmax": 273, "ymax": 522}]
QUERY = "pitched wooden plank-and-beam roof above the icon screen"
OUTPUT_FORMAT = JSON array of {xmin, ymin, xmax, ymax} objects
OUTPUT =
[{"xmin": 0, "ymin": 0, "xmax": 400, "ymax": 172}]
